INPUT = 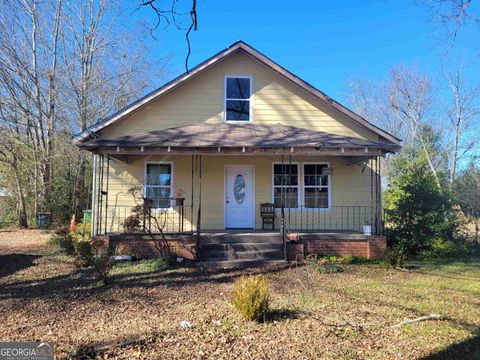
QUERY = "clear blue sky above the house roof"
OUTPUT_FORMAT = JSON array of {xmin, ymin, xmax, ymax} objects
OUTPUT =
[{"xmin": 129, "ymin": 0, "xmax": 480, "ymax": 101}]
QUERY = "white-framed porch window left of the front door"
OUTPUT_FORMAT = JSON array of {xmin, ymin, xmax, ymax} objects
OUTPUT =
[{"xmin": 145, "ymin": 163, "xmax": 173, "ymax": 209}]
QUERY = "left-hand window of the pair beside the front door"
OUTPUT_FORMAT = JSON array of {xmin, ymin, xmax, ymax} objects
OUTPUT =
[{"xmin": 273, "ymin": 164, "xmax": 298, "ymax": 208}]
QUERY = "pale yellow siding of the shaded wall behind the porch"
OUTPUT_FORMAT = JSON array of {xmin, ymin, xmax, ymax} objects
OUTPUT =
[{"xmin": 97, "ymin": 155, "xmax": 371, "ymax": 232}]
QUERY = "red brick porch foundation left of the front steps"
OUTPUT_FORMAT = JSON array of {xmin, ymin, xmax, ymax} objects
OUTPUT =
[{"xmin": 93, "ymin": 234, "xmax": 197, "ymax": 260}]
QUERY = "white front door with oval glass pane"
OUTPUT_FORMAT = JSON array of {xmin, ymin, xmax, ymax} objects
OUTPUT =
[{"xmin": 225, "ymin": 165, "xmax": 255, "ymax": 229}]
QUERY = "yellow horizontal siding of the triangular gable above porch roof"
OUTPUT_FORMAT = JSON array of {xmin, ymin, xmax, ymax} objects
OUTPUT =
[{"xmin": 101, "ymin": 52, "xmax": 378, "ymax": 140}]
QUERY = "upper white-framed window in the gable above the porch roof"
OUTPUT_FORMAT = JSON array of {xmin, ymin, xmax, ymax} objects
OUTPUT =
[{"xmin": 225, "ymin": 76, "xmax": 252, "ymax": 122}]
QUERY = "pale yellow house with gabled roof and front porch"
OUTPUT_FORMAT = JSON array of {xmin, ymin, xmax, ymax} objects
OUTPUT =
[{"xmin": 74, "ymin": 41, "xmax": 401, "ymax": 260}]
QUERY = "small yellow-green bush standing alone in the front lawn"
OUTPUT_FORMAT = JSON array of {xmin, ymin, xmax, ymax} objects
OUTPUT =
[{"xmin": 231, "ymin": 275, "xmax": 270, "ymax": 321}]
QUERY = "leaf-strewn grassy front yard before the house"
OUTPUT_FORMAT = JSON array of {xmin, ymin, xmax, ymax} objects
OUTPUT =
[{"xmin": 0, "ymin": 231, "xmax": 480, "ymax": 359}]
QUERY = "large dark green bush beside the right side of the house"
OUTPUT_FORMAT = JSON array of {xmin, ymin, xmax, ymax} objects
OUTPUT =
[{"xmin": 385, "ymin": 151, "xmax": 458, "ymax": 255}]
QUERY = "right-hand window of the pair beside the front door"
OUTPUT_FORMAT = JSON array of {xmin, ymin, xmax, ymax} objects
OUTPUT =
[{"xmin": 303, "ymin": 164, "xmax": 330, "ymax": 209}]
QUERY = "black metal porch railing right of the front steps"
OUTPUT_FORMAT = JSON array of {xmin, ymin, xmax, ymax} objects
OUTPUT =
[{"xmin": 279, "ymin": 205, "xmax": 378, "ymax": 234}]
